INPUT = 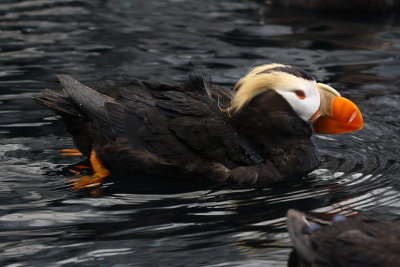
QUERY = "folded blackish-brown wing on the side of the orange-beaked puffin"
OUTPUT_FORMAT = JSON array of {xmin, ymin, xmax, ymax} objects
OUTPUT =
[{"xmin": 106, "ymin": 76, "xmax": 253, "ymax": 168}]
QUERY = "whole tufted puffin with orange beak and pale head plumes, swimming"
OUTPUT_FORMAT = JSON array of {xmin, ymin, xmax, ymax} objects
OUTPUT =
[{"xmin": 35, "ymin": 64, "xmax": 363, "ymax": 188}]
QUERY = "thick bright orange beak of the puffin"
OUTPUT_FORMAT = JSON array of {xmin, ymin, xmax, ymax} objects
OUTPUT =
[{"xmin": 314, "ymin": 96, "xmax": 364, "ymax": 134}]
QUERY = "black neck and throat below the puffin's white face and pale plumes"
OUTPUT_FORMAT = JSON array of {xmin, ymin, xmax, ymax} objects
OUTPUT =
[{"xmin": 231, "ymin": 90, "xmax": 317, "ymax": 176}]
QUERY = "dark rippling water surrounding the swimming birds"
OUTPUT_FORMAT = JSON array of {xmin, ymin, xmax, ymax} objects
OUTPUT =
[{"xmin": 0, "ymin": 0, "xmax": 400, "ymax": 267}]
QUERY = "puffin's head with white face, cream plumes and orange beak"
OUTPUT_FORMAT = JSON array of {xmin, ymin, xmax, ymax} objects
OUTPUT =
[{"xmin": 227, "ymin": 64, "xmax": 363, "ymax": 134}]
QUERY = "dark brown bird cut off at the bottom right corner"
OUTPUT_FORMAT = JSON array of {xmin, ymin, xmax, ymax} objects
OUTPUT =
[{"xmin": 287, "ymin": 210, "xmax": 400, "ymax": 267}]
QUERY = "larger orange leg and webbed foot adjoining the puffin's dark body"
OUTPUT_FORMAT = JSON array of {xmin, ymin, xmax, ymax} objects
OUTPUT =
[{"xmin": 71, "ymin": 149, "xmax": 111, "ymax": 190}]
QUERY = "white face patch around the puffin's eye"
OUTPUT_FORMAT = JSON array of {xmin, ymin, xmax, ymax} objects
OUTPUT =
[{"xmin": 275, "ymin": 77, "xmax": 321, "ymax": 121}]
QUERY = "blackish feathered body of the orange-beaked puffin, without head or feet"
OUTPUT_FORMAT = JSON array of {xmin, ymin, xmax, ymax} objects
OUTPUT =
[{"xmin": 35, "ymin": 75, "xmax": 319, "ymax": 184}]
